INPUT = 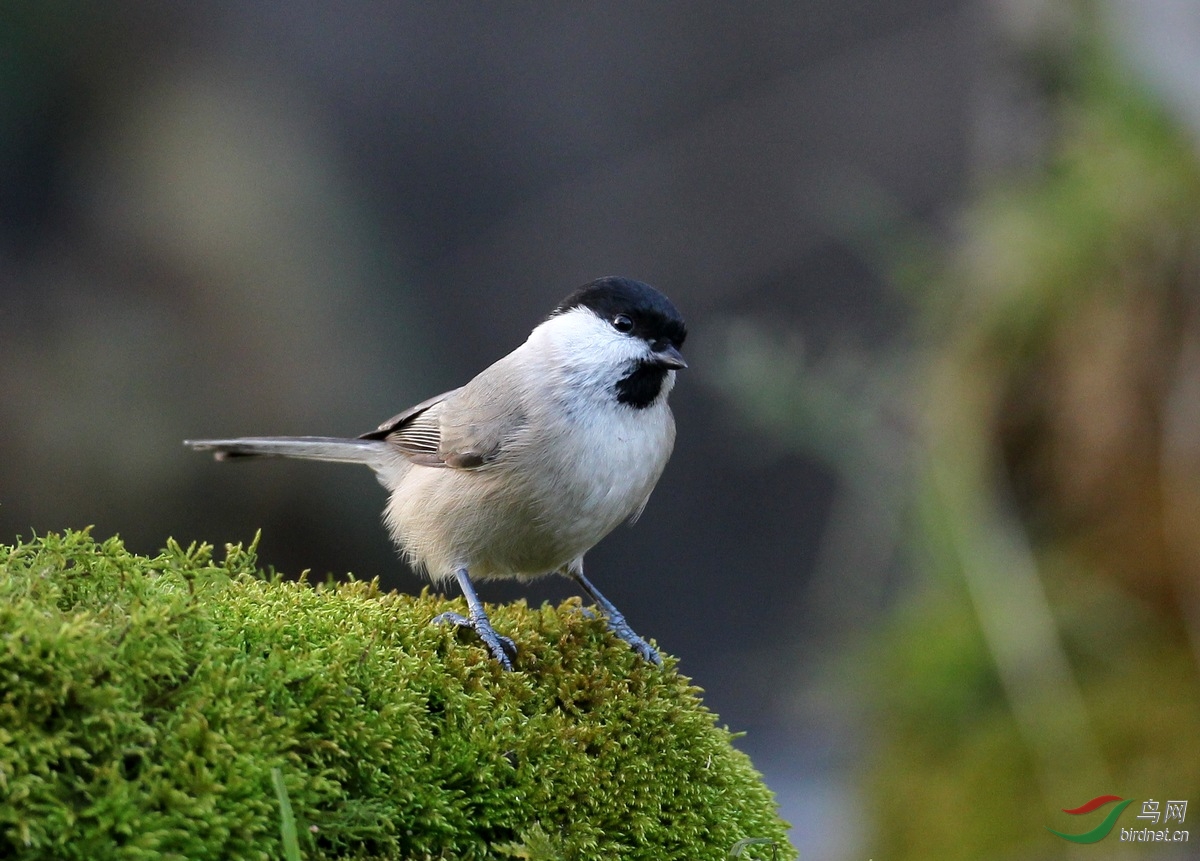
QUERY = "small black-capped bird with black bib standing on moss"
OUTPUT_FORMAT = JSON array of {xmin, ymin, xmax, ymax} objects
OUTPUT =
[{"xmin": 185, "ymin": 276, "xmax": 688, "ymax": 670}]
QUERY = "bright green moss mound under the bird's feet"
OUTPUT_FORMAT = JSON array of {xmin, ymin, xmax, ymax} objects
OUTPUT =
[{"xmin": 0, "ymin": 532, "xmax": 794, "ymax": 861}]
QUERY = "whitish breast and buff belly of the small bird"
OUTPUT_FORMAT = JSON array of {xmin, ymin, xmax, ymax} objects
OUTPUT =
[{"xmin": 386, "ymin": 403, "xmax": 674, "ymax": 587}]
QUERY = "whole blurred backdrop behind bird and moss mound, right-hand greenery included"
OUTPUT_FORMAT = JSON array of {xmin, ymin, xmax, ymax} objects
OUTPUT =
[{"xmin": 0, "ymin": 0, "xmax": 1200, "ymax": 860}]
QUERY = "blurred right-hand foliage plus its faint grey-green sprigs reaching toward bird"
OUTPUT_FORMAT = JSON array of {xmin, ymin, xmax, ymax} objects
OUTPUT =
[{"xmin": 716, "ymin": 11, "xmax": 1200, "ymax": 861}]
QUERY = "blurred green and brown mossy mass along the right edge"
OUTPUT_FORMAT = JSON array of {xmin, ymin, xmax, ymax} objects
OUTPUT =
[{"xmin": 866, "ymin": 33, "xmax": 1200, "ymax": 861}]
